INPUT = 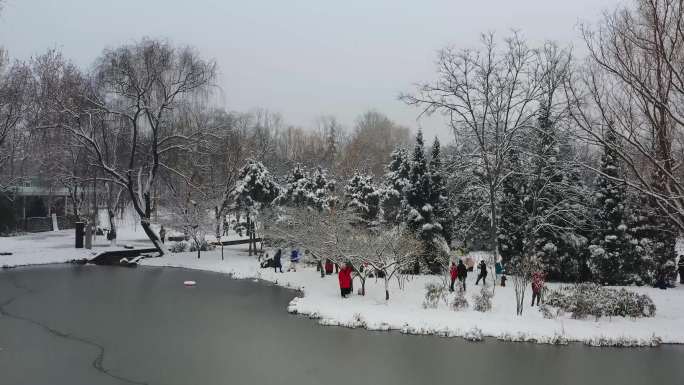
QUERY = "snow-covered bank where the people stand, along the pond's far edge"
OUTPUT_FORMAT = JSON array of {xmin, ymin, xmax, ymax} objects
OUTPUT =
[{"xmin": 143, "ymin": 247, "xmax": 684, "ymax": 346}]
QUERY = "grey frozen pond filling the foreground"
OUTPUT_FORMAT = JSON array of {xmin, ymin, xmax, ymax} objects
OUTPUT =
[{"xmin": 0, "ymin": 265, "xmax": 684, "ymax": 385}]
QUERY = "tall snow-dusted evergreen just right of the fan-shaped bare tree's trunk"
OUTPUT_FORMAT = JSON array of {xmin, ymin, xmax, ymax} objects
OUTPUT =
[{"xmin": 498, "ymin": 110, "xmax": 586, "ymax": 281}]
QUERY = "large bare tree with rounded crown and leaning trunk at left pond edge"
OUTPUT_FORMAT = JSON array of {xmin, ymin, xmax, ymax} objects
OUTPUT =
[{"xmin": 57, "ymin": 39, "xmax": 216, "ymax": 254}]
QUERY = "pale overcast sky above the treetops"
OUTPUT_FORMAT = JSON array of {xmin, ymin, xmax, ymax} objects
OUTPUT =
[{"xmin": 0, "ymin": 0, "xmax": 621, "ymax": 139}]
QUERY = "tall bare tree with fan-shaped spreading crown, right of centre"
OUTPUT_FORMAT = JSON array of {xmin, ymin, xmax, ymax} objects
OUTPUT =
[{"xmin": 401, "ymin": 33, "xmax": 569, "ymax": 270}]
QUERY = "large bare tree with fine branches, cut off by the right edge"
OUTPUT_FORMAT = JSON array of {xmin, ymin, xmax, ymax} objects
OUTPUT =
[{"xmin": 566, "ymin": 0, "xmax": 684, "ymax": 231}]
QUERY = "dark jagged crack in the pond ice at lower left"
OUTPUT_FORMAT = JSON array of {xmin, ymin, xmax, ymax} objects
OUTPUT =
[{"xmin": 0, "ymin": 274, "xmax": 148, "ymax": 385}]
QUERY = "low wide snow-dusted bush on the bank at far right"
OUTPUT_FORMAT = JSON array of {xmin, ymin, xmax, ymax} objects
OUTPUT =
[{"xmin": 545, "ymin": 283, "xmax": 656, "ymax": 319}]
